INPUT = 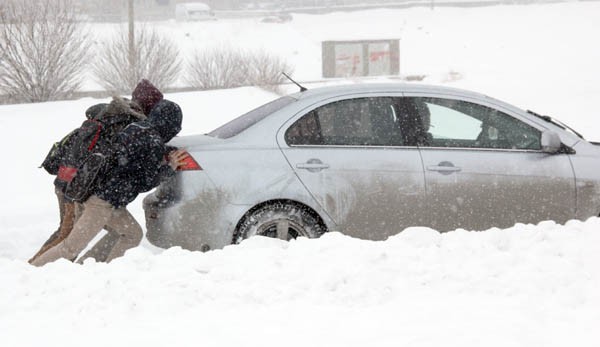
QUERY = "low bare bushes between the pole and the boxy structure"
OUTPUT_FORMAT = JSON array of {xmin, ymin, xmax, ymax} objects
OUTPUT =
[{"xmin": 186, "ymin": 47, "xmax": 292, "ymax": 92}]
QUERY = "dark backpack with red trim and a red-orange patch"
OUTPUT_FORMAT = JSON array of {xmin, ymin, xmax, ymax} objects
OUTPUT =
[{"xmin": 57, "ymin": 120, "xmax": 110, "ymax": 202}]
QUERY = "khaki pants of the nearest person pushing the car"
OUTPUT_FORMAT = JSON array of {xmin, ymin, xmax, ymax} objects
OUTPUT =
[{"xmin": 31, "ymin": 195, "xmax": 143, "ymax": 266}]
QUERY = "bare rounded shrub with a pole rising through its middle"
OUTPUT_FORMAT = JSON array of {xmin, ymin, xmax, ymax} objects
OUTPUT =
[{"xmin": 93, "ymin": 27, "xmax": 182, "ymax": 92}]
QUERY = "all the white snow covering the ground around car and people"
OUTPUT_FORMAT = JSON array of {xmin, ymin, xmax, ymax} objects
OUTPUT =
[{"xmin": 0, "ymin": 2, "xmax": 600, "ymax": 347}]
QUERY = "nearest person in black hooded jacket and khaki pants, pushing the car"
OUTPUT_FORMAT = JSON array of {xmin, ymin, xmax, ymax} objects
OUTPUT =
[{"xmin": 32, "ymin": 86, "xmax": 186, "ymax": 266}]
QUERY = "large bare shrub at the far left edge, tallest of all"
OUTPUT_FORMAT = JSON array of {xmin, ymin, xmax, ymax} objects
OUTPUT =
[{"xmin": 0, "ymin": 0, "xmax": 89, "ymax": 102}]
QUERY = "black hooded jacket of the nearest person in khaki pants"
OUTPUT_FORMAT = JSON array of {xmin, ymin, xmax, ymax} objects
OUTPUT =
[{"xmin": 95, "ymin": 100, "xmax": 182, "ymax": 207}]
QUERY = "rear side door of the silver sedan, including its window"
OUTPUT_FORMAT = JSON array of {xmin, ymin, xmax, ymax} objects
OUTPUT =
[{"xmin": 278, "ymin": 96, "xmax": 426, "ymax": 240}]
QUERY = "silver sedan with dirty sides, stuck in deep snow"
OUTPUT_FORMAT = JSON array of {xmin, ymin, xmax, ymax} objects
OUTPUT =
[{"xmin": 144, "ymin": 84, "xmax": 600, "ymax": 250}]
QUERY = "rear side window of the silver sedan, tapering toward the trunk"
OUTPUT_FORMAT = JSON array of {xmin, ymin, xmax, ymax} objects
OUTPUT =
[{"xmin": 285, "ymin": 97, "xmax": 404, "ymax": 146}]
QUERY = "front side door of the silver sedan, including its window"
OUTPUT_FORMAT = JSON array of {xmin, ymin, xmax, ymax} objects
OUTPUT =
[{"xmin": 403, "ymin": 95, "xmax": 576, "ymax": 231}]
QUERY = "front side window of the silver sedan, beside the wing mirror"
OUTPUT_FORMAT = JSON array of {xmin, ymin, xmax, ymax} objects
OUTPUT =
[{"xmin": 405, "ymin": 98, "xmax": 541, "ymax": 150}]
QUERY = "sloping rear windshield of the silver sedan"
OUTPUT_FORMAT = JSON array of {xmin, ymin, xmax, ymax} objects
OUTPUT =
[{"xmin": 207, "ymin": 96, "xmax": 296, "ymax": 139}]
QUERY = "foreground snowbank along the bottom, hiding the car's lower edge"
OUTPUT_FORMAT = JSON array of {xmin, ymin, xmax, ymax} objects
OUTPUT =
[{"xmin": 0, "ymin": 226, "xmax": 600, "ymax": 347}]
